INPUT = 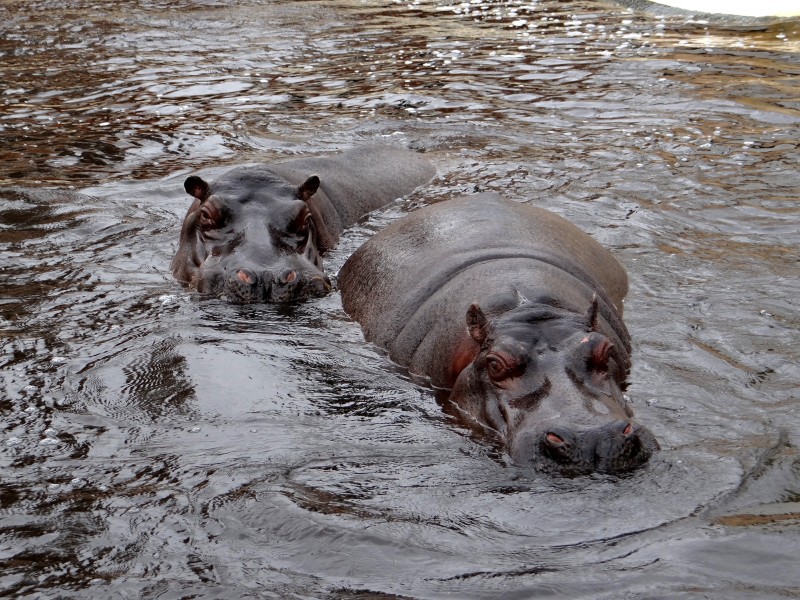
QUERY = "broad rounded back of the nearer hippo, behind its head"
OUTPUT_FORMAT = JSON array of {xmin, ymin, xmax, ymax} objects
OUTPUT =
[{"xmin": 339, "ymin": 194, "xmax": 630, "ymax": 387}]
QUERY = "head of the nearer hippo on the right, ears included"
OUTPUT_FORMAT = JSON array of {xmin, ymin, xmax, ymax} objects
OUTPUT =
[{"xmin": 450, "ymin": 298, "xmax": 659, "ymax": 475}]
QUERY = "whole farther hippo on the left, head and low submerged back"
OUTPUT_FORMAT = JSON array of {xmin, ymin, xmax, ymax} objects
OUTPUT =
[{"xmin": 172, "ymin": 146, "xmax": 434, "ymax": 303}]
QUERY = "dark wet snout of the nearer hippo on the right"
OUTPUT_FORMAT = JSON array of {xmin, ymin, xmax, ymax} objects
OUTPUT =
[{"xmin": 538, "ymin": 421, "xmax": 659, "ymax": 473}]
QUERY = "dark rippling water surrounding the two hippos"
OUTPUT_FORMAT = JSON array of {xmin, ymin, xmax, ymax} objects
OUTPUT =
[{"xmin": 0, "ymin": 0, "xmax": 800, "ymax": 599}]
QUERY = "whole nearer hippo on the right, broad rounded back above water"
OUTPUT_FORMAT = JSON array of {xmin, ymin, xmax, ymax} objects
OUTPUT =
[{"xmin": 339, "ymin": 194, "xmax": 658, "ymax": 474}]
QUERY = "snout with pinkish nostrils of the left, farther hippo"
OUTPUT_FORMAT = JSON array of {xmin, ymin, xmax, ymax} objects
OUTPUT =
[{"xmin": 214, "ymin": 267, "xmax": 331, "ymax": 304}]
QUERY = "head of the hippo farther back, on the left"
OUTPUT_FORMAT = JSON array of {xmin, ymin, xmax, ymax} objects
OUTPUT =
[{"xmin": 172, "ymin": 167, "xmax": 331, "ymax": 303}]
